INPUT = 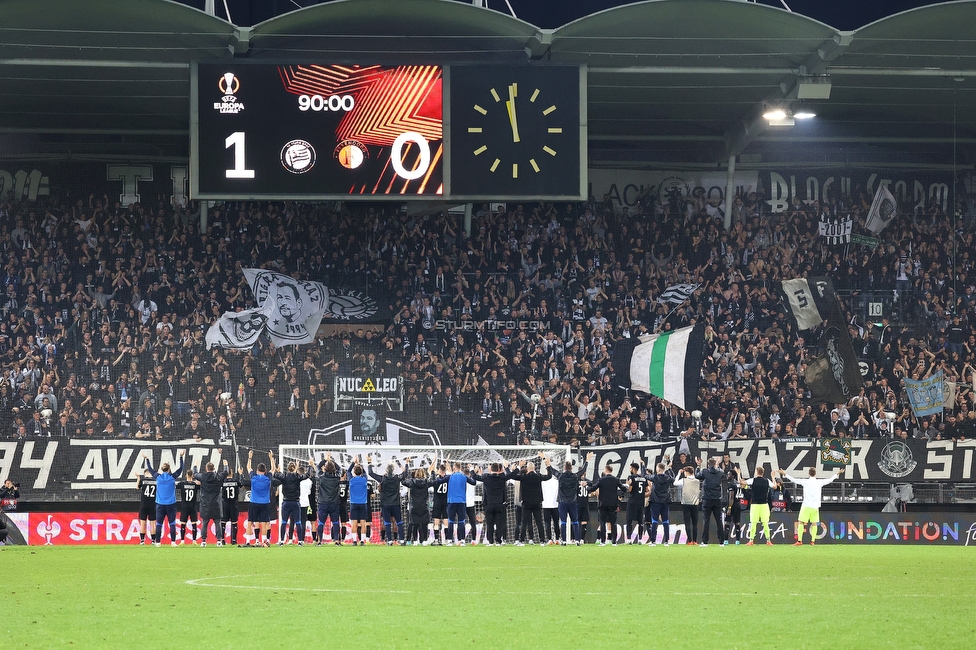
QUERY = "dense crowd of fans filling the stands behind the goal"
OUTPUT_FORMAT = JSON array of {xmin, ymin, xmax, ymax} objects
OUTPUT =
[{"xmin": 0, "ymin": 181, "xmax": 976, "ymax": 446}]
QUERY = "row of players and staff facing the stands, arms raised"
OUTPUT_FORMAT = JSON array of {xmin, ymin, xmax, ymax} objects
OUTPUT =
[{"xmin": 132, "ymin": 452, "xmax": 840, "ymax": 546}]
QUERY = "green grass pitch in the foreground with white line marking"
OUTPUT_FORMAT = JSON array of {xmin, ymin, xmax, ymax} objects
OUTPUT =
[{"xmin": 0, "ymin": 545, "xmax": 976, "ymax": 649}]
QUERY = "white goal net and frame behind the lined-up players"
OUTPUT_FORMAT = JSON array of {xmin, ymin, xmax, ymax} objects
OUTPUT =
[{"xmin": 279, "ymin": 445, "xmax": 579, "ymax": 544}]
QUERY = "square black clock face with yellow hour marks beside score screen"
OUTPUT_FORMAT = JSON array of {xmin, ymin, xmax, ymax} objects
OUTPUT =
[{"xmin": 451, "ymin": 66, "xmax": 582, "ymax": 198}]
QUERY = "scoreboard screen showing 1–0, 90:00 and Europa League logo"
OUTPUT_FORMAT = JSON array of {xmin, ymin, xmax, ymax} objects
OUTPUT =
[{"xmin": 190, "ymin": 61, "xmax": 444, "ymax": 199}]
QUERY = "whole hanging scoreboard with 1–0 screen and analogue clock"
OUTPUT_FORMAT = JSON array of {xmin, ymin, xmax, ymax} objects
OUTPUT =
[{"xmin": 190, "ymin": 61, "xmax": 586, "ymax": 200}]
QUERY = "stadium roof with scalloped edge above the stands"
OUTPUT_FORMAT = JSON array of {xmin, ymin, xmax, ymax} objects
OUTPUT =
[{"xmin": 0, "ymin": 0, "xmax": 976, "ymax": 168}]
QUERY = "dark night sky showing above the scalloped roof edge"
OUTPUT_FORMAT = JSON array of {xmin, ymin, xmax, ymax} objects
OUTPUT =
[{"xmin": 178, "ymin": 0, "xmax": 937, "ymax": 30}]
